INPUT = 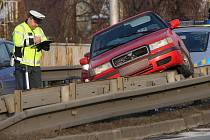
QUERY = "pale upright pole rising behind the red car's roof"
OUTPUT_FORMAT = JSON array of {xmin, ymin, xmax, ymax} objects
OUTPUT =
[{"xmin": 109, "ymin": 0, "xmax": 119, "ymax": 25}]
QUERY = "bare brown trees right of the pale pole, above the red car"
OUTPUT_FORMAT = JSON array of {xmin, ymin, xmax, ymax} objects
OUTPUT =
[{"xmin": 121, "ymin": 0, "xmax": 207, "ymax": 20}]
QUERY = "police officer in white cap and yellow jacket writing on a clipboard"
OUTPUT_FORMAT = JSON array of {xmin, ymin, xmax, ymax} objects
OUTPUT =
[{"xmin": 13, "ymin": 10, "xmax": 49, "ymax": 90}]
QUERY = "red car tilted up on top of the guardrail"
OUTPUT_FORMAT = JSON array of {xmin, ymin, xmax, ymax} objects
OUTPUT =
[{"xmin": 80, "ymin": 11, "xmax": 194, "ymax": 82}]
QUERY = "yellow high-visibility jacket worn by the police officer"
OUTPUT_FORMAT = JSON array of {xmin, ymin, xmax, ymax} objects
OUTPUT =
[{"xmin": 12, "ymin": 22, "xmax": 47, "ymax": 66}]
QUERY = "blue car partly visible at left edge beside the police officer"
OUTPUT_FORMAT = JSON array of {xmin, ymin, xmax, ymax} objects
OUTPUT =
[{"xmin": 0, "ymin": 41, "xmax": 15, "ymax": 94}]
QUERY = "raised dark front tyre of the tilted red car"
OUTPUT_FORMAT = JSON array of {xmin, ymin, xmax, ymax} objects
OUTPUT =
[{"xmin": 177, "ymin": 54, "xmax": 194, "ymax": 78}]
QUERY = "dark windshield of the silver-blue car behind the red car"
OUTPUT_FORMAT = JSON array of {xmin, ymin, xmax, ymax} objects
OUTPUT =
[{"xmin": 176, "ymin": 31, "xmax": 209, "ymax": 52}]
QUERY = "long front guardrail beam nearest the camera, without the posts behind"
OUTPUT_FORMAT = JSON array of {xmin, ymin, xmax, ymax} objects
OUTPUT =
[{"xmin": 0, "ymin": 76, "xmax": 210, "ymax": 135}]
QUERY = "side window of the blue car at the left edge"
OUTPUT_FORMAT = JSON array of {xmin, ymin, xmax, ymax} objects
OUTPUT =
[{"xmin": 0, "ymin": 43, "xmax": 10, "ymax": 63}]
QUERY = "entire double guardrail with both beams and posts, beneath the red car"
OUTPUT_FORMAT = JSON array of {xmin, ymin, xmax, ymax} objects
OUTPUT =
[{"xmin": 0, "ymin": 67, "xmax": 210, "ymax": 134}]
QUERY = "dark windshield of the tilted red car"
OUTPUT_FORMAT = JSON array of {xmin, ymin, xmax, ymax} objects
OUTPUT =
[{"xmin": 91, "ymin": 13, "xmax": 167, "ymax": 57}]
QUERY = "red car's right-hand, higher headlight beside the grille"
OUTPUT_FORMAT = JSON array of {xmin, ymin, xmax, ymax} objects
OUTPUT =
[{"xmin": 149, "ymin": 37, "xmax": 173, "ymax": 51}]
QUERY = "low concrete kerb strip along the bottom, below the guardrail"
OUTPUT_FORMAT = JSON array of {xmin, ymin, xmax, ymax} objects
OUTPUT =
[{"xmin": 42, "ymin": 110, "xmax": 210, "ymax": 140}]
